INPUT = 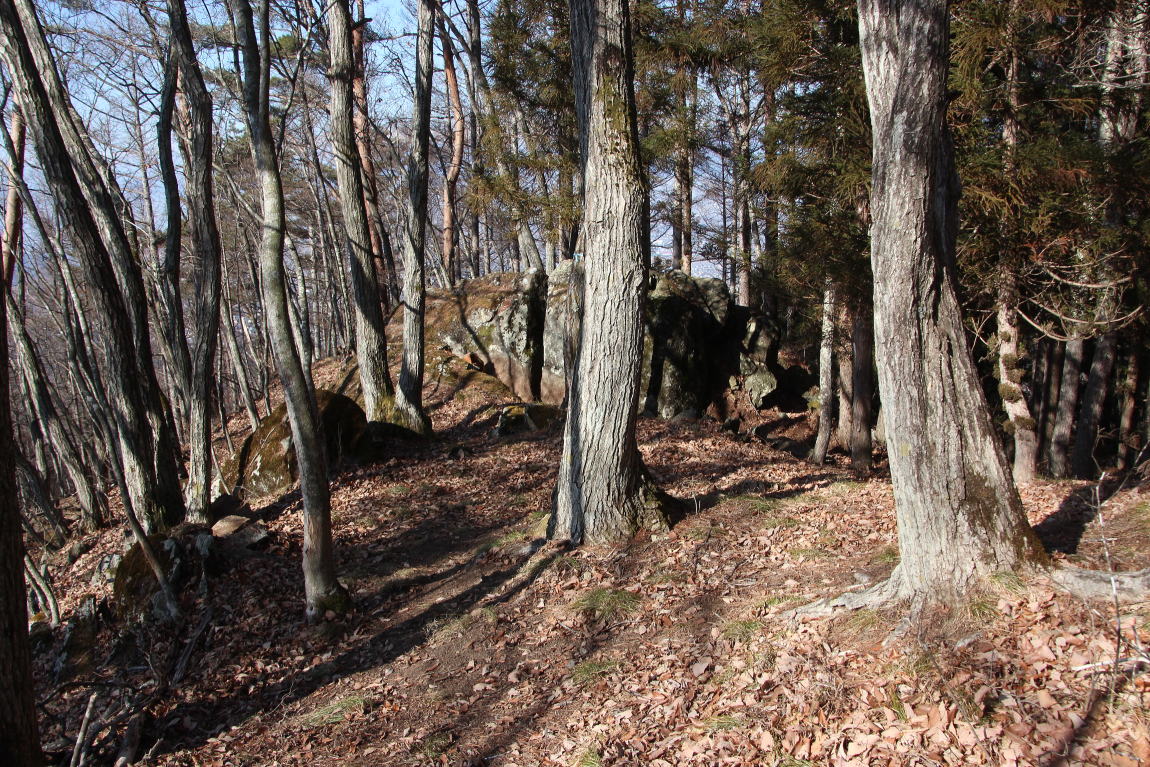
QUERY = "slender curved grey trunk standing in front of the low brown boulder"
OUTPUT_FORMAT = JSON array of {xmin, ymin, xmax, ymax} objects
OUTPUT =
[{"xmin": 230, "ymin": 0, "xmax": 350, "ymax": 620}]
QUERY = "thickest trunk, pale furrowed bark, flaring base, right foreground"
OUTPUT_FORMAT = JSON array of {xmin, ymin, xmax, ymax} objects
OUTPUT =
[{"xmin": 856, "ymin": 0, "xmax": 1044, "ymax": 600}]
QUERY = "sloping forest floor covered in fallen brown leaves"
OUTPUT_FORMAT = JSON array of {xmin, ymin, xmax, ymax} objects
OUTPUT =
[{"xmin": 29, "ymin": 358, "xmax": 1150, "ymax": 767}]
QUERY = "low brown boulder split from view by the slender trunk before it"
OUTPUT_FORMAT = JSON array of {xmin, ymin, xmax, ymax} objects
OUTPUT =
[{"xmin": 220, "ymin": 389, "xmax": 369, "ymax": 498}]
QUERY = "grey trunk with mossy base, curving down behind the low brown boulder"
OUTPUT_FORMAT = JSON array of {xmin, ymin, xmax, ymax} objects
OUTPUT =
[{"xmin": 328, "ymin": 0, "xmax": 394, "ymax": 421}]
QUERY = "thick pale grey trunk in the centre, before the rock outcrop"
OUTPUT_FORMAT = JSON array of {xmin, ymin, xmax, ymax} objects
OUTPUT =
[{"xmin": 549, "ymin": 0, "xmax": 667, "ymax": 543}]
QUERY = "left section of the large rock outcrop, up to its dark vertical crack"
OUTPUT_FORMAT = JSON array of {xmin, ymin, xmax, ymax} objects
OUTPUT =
[{"xmin": 426, "ymin": 269, "xmax": 547, "ymax": 400}]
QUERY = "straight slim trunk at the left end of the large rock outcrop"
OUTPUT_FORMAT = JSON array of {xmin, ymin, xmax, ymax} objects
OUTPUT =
[{"xmin": 396, "ymin": 0, "xmax": 435, "ymax": 434}]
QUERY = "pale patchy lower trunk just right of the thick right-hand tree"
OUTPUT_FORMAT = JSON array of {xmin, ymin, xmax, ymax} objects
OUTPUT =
[{"xmin": 997, "ymin": 280, "xmax": 1038, "ymax": 484}]
